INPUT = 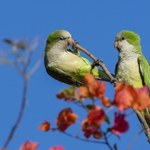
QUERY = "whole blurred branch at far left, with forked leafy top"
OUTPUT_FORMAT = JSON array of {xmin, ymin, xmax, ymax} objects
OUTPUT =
[{"xmin": 0, "ymin": 39, "xmax": 41, "ymax": 150}]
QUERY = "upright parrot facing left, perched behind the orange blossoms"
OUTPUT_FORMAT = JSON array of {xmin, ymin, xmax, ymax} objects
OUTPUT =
[{"xmin": 114, "ymin": 30, "xmax": 150, "ymax": 136}]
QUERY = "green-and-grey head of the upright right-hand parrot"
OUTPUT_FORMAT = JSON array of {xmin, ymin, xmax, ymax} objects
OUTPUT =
[{"xmin": 114, "ymin": 30, "xmax": 141, "ymax": 53}]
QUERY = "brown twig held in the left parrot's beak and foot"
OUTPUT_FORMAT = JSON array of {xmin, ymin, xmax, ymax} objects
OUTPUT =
[{"xmin": 75, "ymin": 44, "xmax": 115, "ymax": 82}]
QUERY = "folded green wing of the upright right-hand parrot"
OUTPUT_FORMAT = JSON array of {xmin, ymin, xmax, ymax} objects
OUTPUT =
[{"xmin": 138, "ymin": 56, "xmax": 150, "ymax": 89}]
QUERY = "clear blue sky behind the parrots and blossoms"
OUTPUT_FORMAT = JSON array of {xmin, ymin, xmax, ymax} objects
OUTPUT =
[{"xmin": 0, "ymin": 0, "xmax": 150, "ymax": 150}]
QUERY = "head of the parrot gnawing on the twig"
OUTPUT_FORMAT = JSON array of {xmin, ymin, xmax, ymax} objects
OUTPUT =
[{"xmin": 47, "ymin": 30, "xmax": 74, "ymax": 47}]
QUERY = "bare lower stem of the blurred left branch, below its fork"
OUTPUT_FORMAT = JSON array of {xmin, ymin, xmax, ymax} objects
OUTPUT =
[{"xmin": 2, "ymin": 78, "xmax": 28, "ymax": 150}]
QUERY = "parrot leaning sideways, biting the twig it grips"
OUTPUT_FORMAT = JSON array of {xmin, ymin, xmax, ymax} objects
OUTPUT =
[{"xmin": 44, "ymin": 30, "xmax": 109, "ymax": 86}]
